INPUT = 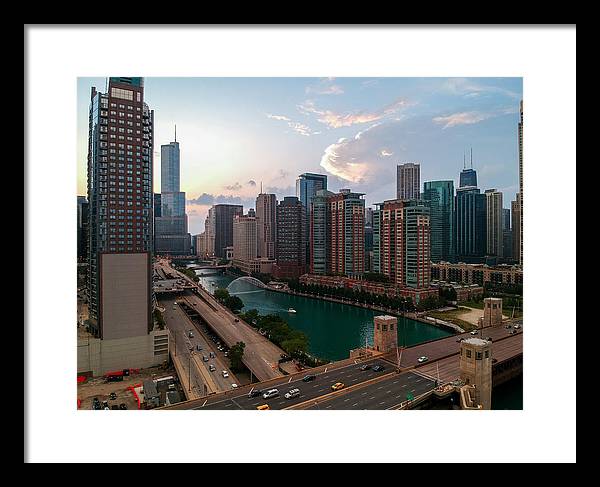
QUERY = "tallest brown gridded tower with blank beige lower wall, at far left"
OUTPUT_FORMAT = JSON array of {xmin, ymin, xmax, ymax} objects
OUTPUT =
[{"xmin": 88, "ymin": 77, "xmax": 154, "ymax": 342}]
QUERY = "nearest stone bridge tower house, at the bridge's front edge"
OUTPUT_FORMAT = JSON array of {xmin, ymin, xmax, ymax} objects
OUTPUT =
[{"xmin": 460, "ymin": 338, "xmax": 492, "ymax": 409}]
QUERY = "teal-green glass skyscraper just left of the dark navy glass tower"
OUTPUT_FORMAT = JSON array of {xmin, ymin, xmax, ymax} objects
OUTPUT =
[{"xmin": 423, "ymin": 181, "xmax": 454, "ymax": 262}]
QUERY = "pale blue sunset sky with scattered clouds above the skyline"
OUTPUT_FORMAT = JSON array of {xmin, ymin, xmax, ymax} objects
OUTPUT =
[{"xmin": 77, "ymin": 77, "xmax": 523, "ymax": 235}]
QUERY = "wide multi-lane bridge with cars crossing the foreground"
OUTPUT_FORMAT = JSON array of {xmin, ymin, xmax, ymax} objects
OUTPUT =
[{"xmin": 162, "ymin": 320, "xmax": 523, "ymax": 411}]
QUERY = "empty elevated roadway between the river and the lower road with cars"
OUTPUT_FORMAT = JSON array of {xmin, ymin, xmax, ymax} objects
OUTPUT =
[{"xmin": 157, "ymin": 260, "xmax": 284, "ymax": 381}]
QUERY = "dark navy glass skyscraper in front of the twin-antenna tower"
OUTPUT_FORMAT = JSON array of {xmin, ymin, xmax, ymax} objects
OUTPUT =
[{"xmin": 454, "ymin": 186, "xmax": 487, "ymax": 263}]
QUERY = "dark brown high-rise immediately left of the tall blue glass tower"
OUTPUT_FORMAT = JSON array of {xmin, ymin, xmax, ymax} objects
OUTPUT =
[{"xmin": 273, "ymin": 196, "xmax": 306, "ymax": 278}]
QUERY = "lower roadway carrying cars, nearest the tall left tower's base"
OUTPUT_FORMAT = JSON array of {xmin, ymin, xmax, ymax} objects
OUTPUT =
[{"xmin": 159, "ymin": 298, "xmax": 237, "ymax": 396}]
